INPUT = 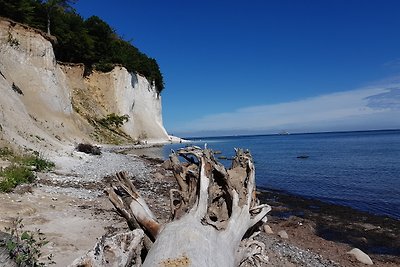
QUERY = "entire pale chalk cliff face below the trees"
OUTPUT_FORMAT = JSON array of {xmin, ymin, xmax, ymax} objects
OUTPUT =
[{"xmin": 0, "ymin": 19, "xmax": 168, "ymax": 154}]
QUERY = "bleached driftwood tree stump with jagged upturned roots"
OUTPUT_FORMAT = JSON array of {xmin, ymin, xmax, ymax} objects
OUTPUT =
[{"xmin": 72, "ymin": 147, "xmax": 271, "ymax": 267}]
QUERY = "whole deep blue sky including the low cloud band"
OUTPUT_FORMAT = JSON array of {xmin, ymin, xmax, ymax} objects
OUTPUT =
[{"xmin": 75, "ymin": 0, "xmax": 400, "ymax": 136}]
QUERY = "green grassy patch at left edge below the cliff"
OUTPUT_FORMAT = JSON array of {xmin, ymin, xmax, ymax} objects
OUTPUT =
[{"xmin": 0, "ymin": 147, "xmax": 55, "ymax": 192}]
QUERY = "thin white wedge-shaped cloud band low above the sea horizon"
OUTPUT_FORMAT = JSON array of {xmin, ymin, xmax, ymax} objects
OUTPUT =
[{"xmin": 177, "ymin": 84, "xmax": 400, "ymax": 134}]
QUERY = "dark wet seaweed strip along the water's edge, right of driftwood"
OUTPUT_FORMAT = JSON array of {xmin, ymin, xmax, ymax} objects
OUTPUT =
[{"xmin": 258, "ymin": 188, "xmax": 400, "ymax": 266}]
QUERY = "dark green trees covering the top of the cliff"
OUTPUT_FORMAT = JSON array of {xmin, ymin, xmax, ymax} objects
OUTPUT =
[{"xmin": 0, "ymin": 0, "xmax": 164, "ymax": 92}]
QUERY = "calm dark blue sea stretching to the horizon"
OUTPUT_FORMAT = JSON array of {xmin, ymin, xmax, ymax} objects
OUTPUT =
[{"xmin": 135, "ymin": 130, "xmax": 400, "ymax": 219}]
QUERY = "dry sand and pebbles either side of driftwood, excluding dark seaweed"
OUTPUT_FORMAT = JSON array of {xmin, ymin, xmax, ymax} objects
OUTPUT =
[{"xmin": 0, "ymin": 149, "xmax": 400, "ymax": 267}]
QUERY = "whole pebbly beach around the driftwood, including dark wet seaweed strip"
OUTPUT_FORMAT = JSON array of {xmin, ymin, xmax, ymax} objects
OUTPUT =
[{"xmin": 0, "ymin": 148, "xmax": 400, "ymax": 266}]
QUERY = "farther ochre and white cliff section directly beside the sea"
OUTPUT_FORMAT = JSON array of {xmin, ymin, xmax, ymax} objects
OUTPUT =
[{"xmin": 62, "ymin": 64, "xmax": 168, "ymax": 140}]
